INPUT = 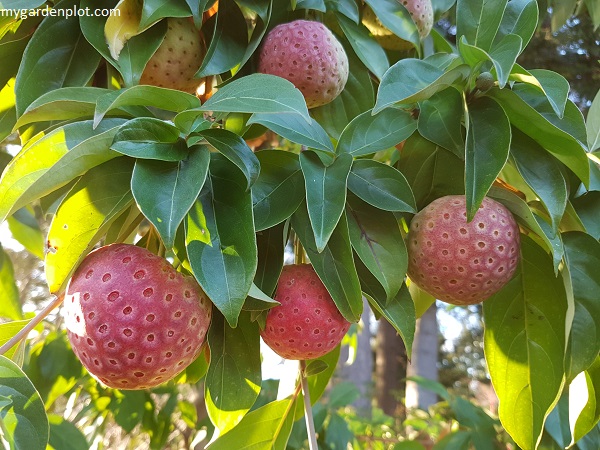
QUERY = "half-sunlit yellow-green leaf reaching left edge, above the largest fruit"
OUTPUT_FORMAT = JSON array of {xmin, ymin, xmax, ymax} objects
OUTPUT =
[{"xmin": 0, "ymin": 119, "xmax": 124, "ymax": 220}]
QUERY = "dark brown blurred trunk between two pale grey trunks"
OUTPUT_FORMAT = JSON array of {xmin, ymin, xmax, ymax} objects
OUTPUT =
[{"xmin": 375, "ymin": 320, "xmax": 406, "ymax": 417}]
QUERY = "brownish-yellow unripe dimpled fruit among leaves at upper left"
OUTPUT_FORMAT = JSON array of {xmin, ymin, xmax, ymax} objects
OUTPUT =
[{"xmin": 139, "ymin": 18, "xmax": 206, "ymax": 94}]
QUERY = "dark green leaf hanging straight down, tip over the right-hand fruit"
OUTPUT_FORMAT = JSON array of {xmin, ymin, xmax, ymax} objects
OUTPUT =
[{"xmin": 465, "ymin": 97, "xmax": 511, "ymax": 221}]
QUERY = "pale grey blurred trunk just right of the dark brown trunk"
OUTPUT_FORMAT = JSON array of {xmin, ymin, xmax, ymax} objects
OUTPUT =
[{"xmin": 406, "ymin": 303, "xmax": 439, "ymax": 409}]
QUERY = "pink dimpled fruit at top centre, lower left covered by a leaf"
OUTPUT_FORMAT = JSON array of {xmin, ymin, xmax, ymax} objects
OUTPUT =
[{"xmin": 258, "ymin": 20, "xmax": 348, "ymax": 108}]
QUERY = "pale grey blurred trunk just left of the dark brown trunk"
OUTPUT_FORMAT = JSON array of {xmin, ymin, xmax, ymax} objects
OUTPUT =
[{"xmin": 337, "ymin": 298, "xmax": 373, "ymax": 418}]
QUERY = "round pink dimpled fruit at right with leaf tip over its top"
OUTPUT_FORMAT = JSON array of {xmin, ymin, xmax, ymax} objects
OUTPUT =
[{"xmin": 407, "ymin": 195, "xmax": 520, "ymax": 305}]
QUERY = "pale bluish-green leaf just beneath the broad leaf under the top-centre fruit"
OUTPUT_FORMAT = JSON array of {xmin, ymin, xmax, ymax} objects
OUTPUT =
[{"xmin": 247, "ymin": 113, "xmax": 333, "ymax": 153}]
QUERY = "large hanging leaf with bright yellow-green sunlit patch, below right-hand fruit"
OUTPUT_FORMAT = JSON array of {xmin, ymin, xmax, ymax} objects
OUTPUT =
[{"xmin": 483, "ymin": 236, "xmax": 567, "ymax": 450}]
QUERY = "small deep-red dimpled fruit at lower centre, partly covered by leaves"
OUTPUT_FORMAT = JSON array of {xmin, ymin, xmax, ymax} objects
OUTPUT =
[{"xmin": 261, "ymin": 264, "xmax": 350, "ymax": 359}]
